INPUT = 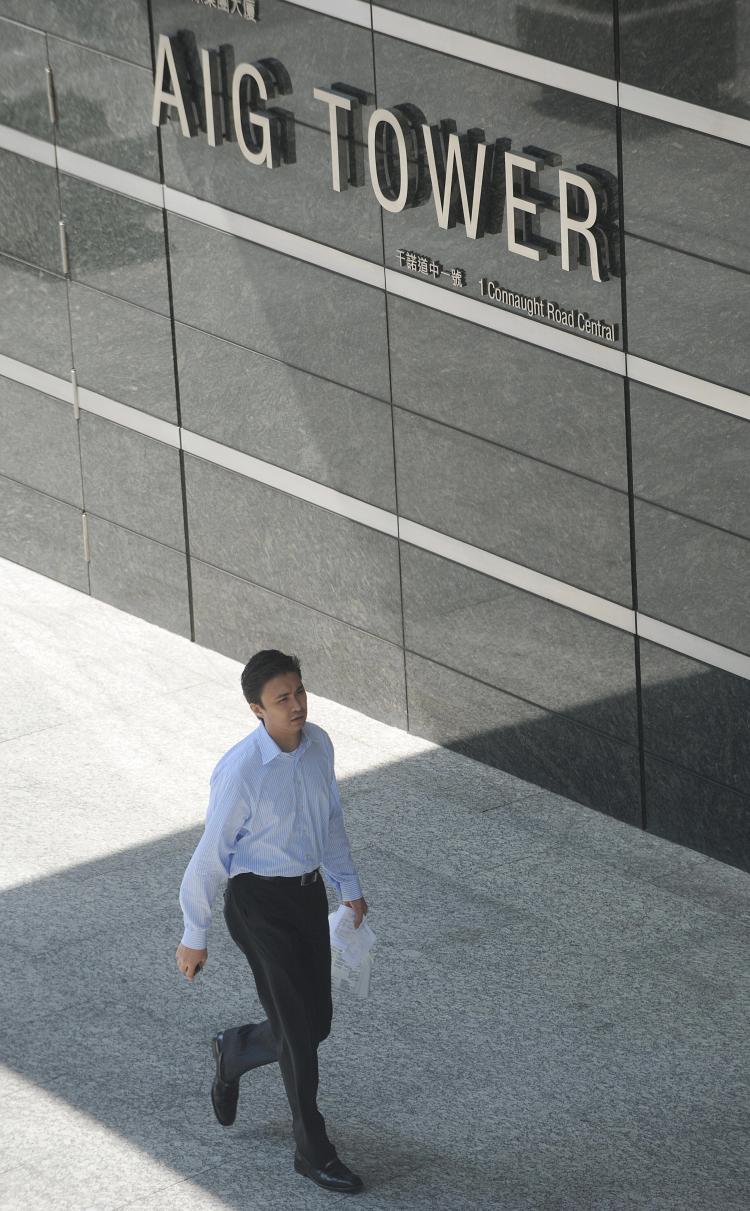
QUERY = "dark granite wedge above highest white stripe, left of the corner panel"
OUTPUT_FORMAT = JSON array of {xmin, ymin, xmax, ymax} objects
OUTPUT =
[{"xmin": 378, "ymin": 0, "xmax": 614, "ymax": 76}]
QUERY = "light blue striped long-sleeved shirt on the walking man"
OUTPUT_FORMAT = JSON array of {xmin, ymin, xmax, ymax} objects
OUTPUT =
[{"xmin": 179, "ymin": 722, "xmax": 362, "ymax": 951}]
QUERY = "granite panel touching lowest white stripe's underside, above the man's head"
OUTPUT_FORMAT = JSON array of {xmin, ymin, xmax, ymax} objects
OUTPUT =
[{"xmin": 185, "ymin": 457, "xmax": 402, "ymax": 643}]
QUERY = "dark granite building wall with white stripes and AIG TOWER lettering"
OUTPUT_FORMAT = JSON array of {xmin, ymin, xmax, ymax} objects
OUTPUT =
[{"xmin": 0, "ymin": 0, "xmax": 750, "ymax": 869}]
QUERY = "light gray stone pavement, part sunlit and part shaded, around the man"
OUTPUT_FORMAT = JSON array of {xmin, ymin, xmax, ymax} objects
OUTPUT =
[{"xmin": 0, "ymin": 561, "xmax": 750, "ymax": 1211}]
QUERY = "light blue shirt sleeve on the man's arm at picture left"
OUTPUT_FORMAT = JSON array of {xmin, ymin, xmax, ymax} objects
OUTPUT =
[{"xmin": 179, "ymin": 770, "xmax": 250, "ymax": 951}]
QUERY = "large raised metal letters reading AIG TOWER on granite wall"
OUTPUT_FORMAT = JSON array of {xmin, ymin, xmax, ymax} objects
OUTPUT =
[{"xmin": 151, "ymin": 31, "xmax": 619, "ymax": 284}]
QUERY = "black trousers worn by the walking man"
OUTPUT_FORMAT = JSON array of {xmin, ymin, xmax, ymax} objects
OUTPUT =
[{"xmin": 216, "ymin": 874, "xmax": 336, "ymax": 1166}]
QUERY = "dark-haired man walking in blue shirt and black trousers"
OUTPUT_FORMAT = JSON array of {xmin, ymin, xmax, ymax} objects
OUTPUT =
[{"xmin": 176, "ymin": 650, "xmax": 367, "ymax": 1194}]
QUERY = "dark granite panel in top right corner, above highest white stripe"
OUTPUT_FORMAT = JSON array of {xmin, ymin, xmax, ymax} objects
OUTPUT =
[{"xmin": 619, "ymin": 0, "xmax": 750, "ymax": 117}]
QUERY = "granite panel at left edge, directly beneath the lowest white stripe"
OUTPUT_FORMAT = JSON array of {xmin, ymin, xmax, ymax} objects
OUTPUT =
[{"xmin": 0, "ymin": 378, "xmax": 82, "ymax": 509}]
